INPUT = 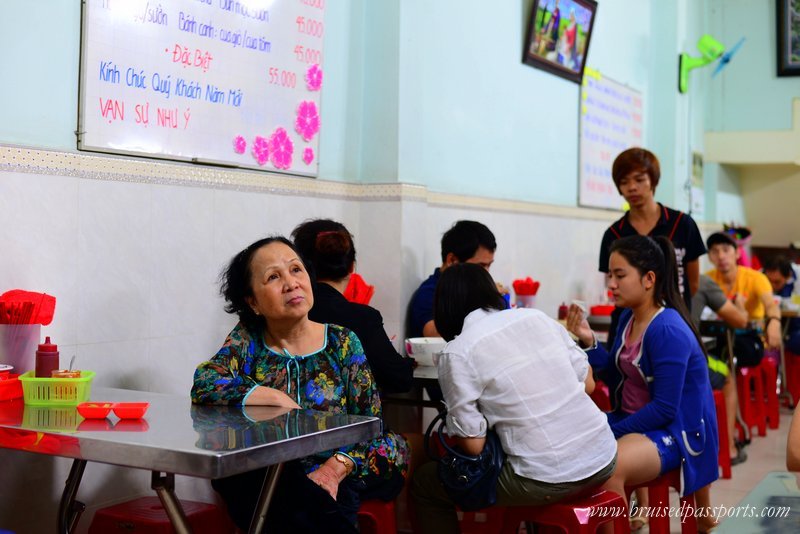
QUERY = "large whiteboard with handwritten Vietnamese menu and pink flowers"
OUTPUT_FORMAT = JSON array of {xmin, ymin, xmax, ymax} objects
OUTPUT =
[{"xmin": 78, "ymin": 0, "xmax": 325, "ymax": 176}]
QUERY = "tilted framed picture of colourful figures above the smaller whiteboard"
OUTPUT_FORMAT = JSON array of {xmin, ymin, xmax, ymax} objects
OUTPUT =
[{"xmin": 522, "ymin": 0, "xmax": 597, "ymax": 83}]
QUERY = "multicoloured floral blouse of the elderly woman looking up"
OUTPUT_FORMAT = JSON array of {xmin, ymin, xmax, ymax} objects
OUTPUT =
[{"xmin": 192, "ymin": 323, "xmax": 408, "ymax": 480}]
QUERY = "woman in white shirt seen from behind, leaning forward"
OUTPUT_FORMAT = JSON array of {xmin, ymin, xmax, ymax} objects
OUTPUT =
[{"xmin": 411, "ymin": 263, "xmax": 617, "ymax": 533}]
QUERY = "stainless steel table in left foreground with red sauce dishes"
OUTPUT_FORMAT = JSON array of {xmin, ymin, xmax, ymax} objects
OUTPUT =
[{"xmin": 0, "ymin": 388, "xmax": 381, "ymax": 534}]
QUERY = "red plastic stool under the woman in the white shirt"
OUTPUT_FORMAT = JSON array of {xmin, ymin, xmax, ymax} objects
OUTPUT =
[{"xmin": 502, "ymin": 490, "xmax": 629, "ymax": 534}]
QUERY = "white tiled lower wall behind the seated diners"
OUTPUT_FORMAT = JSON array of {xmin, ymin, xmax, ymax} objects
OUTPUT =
[{"xmin": 0, "ymin": 152, "xmax": 612, "ymax": 532}]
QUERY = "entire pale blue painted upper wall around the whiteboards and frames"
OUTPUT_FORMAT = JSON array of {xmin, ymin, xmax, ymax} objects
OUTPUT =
[{"xmin": 0, "ymin": 0, "xmax": 788, "ymax": 220}]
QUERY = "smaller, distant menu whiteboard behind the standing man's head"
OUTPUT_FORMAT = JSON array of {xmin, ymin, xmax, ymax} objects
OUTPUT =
[{"xmin": 578, "ymin": 67, "xmax": 643, "ymax": 209}]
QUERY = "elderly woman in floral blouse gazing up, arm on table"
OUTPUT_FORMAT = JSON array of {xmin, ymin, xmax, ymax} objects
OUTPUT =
[{"xmin": 192, "ymin": 237, "xmax": 408, "ymax": 532}]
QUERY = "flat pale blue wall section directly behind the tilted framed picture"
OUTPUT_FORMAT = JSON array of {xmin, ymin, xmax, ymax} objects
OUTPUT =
[{"xmin": 390, "ymin": 0, "xmax": 650, "ymax": 206}]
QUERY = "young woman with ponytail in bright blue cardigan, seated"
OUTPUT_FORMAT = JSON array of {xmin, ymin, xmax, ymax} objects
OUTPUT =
[{"xmin": 567, "ymin": 235, "xmax": 719, "ymax": 526}]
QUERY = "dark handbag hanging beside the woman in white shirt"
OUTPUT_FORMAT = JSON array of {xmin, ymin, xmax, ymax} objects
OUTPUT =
[{"xmin": 425, "ymin": 412, "xmax": 506, "ymax": 512}]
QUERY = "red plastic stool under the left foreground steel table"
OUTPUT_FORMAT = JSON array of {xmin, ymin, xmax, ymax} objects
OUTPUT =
[{"xmin": 89, "ymin": 497, "xmax": 235, "ymax": 534}]
